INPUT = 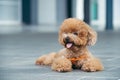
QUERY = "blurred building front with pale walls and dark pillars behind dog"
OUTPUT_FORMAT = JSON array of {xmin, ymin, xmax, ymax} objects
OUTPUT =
[{"xmin": 0, "ymin": 0, "xmax": 120, "ymax": 33}]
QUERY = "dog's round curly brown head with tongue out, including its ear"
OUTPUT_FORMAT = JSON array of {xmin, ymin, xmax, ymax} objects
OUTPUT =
[{"xmin": 59, "ymin": 18, "xmax": 97, "ymax": 49}]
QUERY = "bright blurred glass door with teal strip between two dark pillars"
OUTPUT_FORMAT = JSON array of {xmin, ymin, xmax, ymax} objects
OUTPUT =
[{"xmin": 90, "ymin": 0, "xmax": 106, "ymax": 30}]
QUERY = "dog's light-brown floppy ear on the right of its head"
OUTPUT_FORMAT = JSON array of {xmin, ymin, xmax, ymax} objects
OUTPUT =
[{"xmin": 86, "ymin": 24, "xmax": 97, "ymax": 46}]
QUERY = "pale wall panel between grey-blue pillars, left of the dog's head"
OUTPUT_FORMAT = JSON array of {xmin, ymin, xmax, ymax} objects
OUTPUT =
[{"xmin": 38, "ymin": 0, "xmax": 57, "ymax": 25}]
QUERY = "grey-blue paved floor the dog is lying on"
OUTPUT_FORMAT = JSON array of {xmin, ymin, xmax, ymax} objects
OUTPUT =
[{"xmin": 0, "ymin": 31, "xmax": 120, "ymax": 80}]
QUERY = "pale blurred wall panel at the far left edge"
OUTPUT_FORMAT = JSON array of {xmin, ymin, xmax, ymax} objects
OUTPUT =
[{"xmin": 0, "ymin": 0, "xmax": 21, "ymax": 25}]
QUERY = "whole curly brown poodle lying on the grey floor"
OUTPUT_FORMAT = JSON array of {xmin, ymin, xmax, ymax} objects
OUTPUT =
[{"xmin": 36, "ymin": 18, "xmax": 103, "ymax": 72}]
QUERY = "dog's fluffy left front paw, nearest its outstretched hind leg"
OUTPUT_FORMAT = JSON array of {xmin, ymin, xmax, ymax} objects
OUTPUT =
[{"xmin": 51, "ymin": 57, "xmax": 72, "ymax": 72}]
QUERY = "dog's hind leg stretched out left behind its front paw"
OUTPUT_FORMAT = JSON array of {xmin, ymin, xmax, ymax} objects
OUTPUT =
[{"xmin": 36, "ymin": 52, "xmax": 56, "ymax": 65}]
